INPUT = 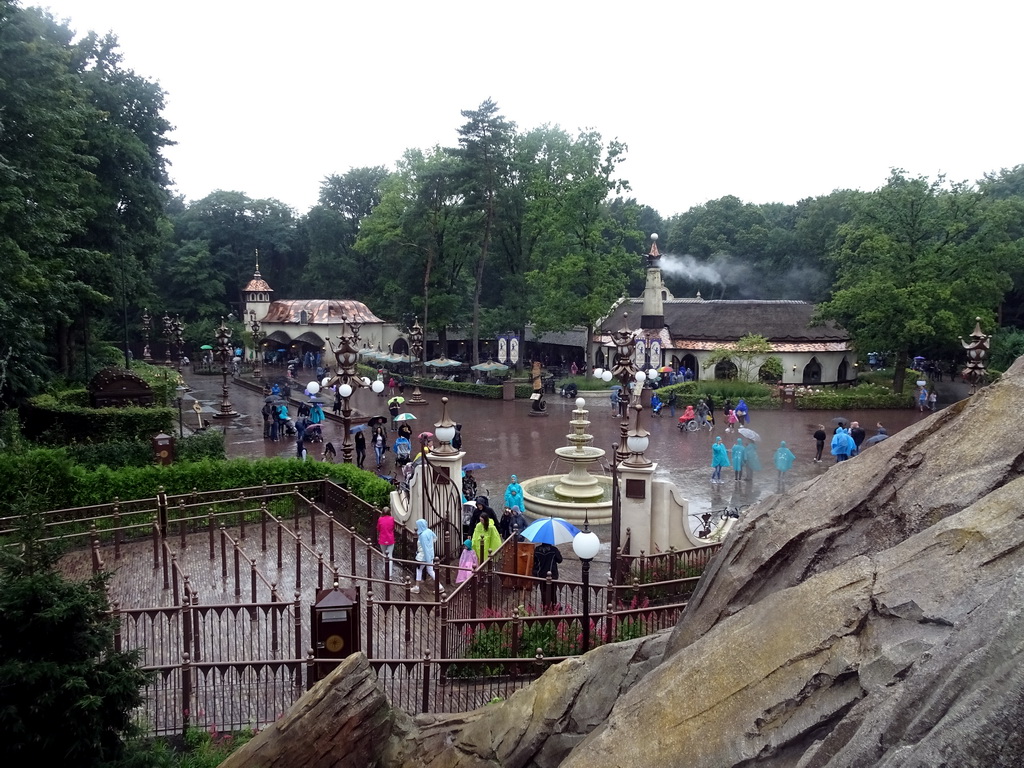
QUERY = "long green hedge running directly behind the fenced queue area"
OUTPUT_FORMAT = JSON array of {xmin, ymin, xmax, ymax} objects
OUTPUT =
[{"xmin": 0, "ymin": 449, "xmax": 391, "ymax": 515}]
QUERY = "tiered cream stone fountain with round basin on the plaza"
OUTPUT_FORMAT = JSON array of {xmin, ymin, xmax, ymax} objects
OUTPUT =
[{"xmin": 522, "ymin": 397, "xmax": 611, "ymax": 524}]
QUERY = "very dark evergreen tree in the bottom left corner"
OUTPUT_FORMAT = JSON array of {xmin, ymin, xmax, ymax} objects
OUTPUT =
[{"xmin": 0, "ymin": 514, "xmax": 148, "ymax": 767}]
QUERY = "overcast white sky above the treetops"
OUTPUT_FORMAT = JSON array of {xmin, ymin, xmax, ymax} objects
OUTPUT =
[{"xmin": 34, "ymin": 0, "xmax": 1024, "ymax": 216}]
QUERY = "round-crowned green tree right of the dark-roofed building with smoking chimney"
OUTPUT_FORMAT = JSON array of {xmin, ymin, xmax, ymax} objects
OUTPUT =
[{"xmin": 819, "ymin": 169, "xmax": 1014, "ymax": 392}]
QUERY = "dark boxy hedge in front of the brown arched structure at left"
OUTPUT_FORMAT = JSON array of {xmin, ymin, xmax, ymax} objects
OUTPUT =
[{"xmin": 24, "ymin": 390, "xmax": 175, "ymax": 444}]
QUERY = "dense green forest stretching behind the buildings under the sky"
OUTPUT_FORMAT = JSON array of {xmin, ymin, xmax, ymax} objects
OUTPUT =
[{"xmin": 0, "ymin": 0, "xmax": 1024, "ymax": 403}]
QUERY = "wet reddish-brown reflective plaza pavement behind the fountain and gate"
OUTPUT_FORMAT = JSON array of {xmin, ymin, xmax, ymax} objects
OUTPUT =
[{"xmin": 184, "ymin": 372, "xmax": 930, "ymax": 520}]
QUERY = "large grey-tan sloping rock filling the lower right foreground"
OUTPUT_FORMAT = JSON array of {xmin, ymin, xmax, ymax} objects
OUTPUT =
[{"xmin": 232, "ymin": 361, "xmax": 1024, "ymax": 768}]
